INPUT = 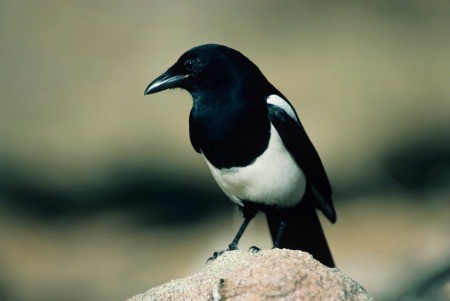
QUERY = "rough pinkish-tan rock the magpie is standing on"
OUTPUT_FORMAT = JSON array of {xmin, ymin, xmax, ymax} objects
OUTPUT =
[{"xmin": 127, "ymin": 249, "xmax": 373, "ymax": 301}]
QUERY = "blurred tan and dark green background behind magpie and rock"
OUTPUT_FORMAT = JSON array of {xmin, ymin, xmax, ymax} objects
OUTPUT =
[{"xmin": 0, "ymin": 0, "xmax": 450, "ymax": 301}]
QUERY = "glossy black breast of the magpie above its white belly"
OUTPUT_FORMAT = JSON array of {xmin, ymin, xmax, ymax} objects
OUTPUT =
[{"xmin": 190, "ymin": 100, "xmax": 270, "ymax": 169}]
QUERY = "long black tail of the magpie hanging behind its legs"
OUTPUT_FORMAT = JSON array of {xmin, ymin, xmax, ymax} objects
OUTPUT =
[{"xmin": 266, "ymin": 190, "xmax": 335, "ymax": 267}]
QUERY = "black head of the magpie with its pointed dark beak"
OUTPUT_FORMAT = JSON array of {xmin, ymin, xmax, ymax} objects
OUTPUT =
[{"xmin": 144, "ymin": 44, "xmax": 265, "ymax": 95}]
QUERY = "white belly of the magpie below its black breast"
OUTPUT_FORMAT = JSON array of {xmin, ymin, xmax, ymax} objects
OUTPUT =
[{"xmin": 205, "ymin": 125, "xmax": 306, "ymax": 207}]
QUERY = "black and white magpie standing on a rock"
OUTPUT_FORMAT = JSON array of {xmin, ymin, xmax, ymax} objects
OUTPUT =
[{"xmin": 144, "ymin": 44, "xmax": 336, "ymax": 267}]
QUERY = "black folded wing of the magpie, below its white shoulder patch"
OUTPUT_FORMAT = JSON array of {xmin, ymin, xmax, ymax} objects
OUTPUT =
[{"xmin": 268, "ymin": 102, "xmax": 336, "ymax": 223}]
